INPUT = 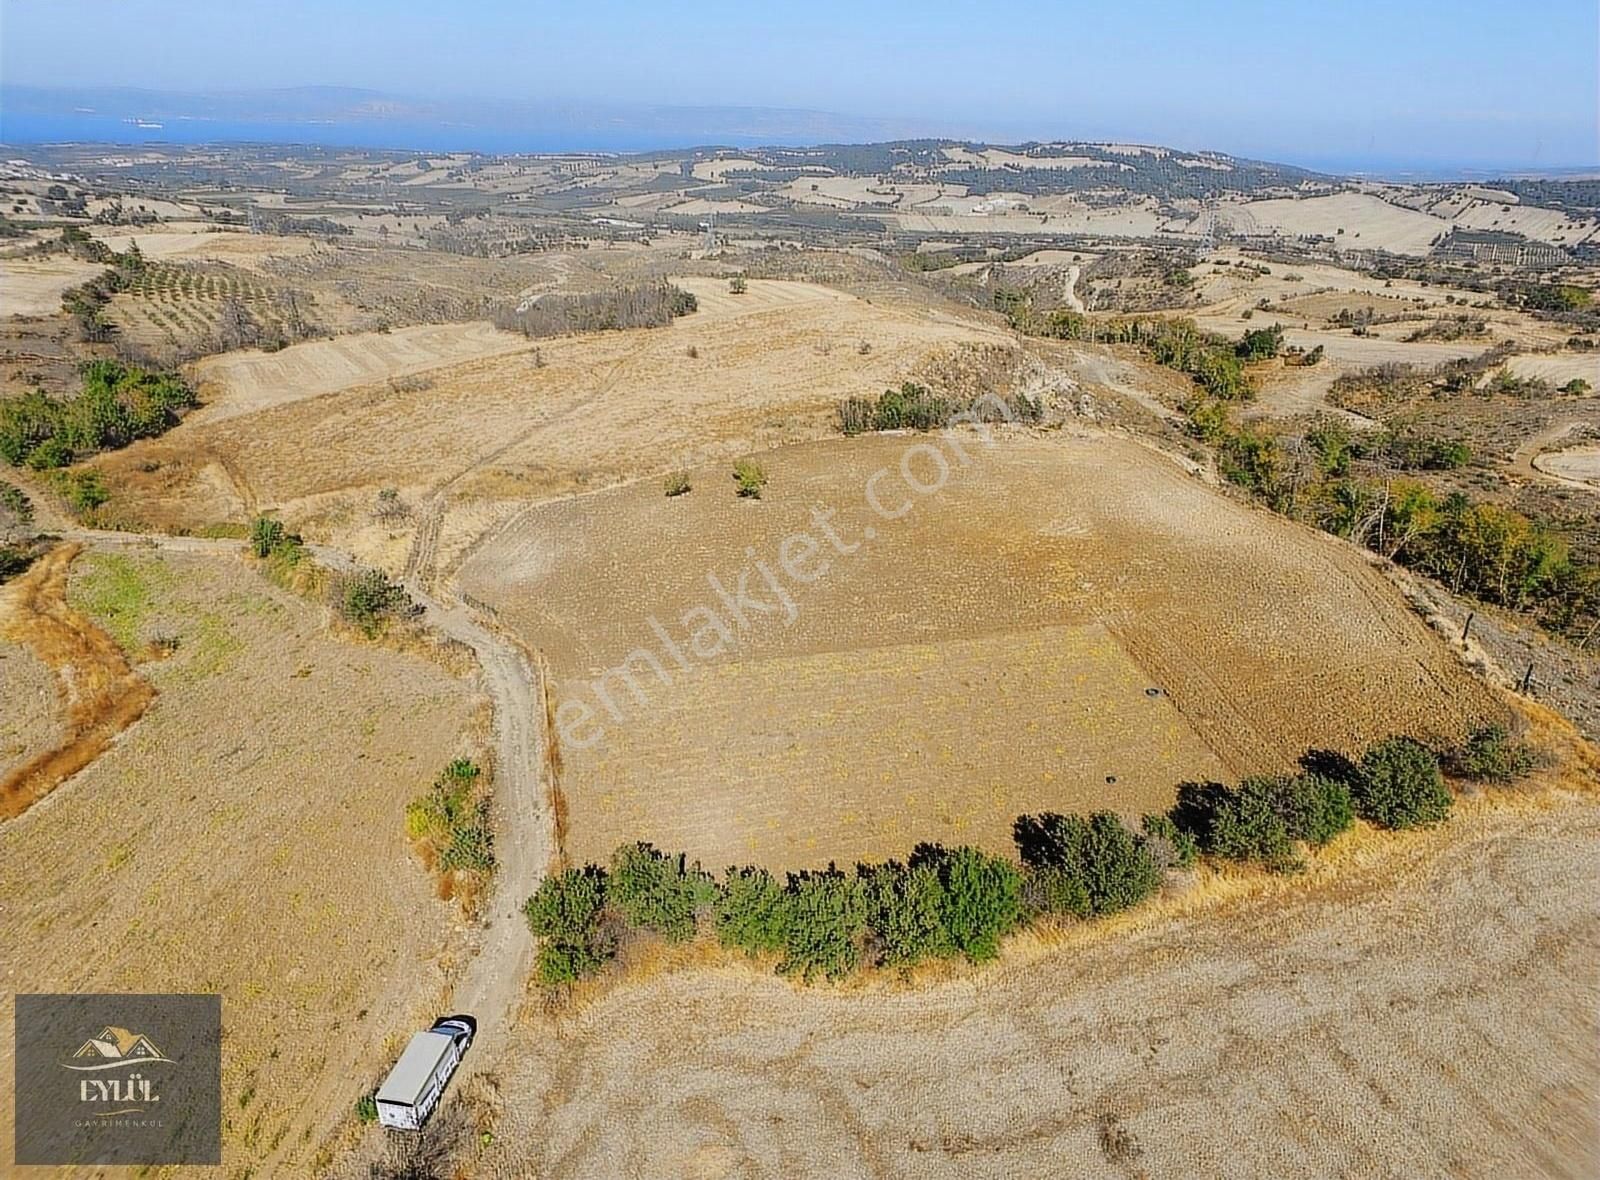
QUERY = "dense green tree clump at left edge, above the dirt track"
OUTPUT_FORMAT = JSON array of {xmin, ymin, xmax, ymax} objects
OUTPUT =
[{"xmin": 0, "ymin": 360, "xmax": 195, "ymax": 470}]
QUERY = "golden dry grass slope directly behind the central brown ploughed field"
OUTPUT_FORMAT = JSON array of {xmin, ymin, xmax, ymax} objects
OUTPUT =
[{"xmin": 101, "ymin": 278, "xmax": 1005, "ymax": 569}]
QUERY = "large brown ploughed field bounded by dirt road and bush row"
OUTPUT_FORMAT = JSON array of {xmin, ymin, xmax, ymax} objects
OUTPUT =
[{"xmin": 461, "ymin": 435, "xmax": 1501, "ymax": 868}]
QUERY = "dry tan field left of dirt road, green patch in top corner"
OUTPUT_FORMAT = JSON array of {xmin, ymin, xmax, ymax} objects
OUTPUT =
[{"xmin": 0, "ymin": 550, "xmax": 478, "ymax": 1175}]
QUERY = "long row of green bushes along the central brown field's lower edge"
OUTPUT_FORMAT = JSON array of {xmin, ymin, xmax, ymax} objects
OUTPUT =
[{"xmin": 523, "ymin": 728, "xmax": 1531, "ymax": 985}]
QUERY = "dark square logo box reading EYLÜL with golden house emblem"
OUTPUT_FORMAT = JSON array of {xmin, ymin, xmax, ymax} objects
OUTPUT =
[{"xmin": 14, "ymin": 995, "xmax": 222, "ymax": 1166}]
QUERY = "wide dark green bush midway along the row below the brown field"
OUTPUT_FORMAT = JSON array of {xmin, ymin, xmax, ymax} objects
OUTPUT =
[{"xmin": 1013, "ymin": 811, "xmax": 1162, "ymax": 916}]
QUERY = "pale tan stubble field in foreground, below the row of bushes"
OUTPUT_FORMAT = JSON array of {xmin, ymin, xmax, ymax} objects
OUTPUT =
[{"xmin": 474, "ymin": 777, "xmax": 1600, "ymax": 1180}]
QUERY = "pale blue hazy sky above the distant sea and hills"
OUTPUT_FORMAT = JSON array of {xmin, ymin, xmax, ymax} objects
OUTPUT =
[{"xmin": 0, "ymin": 0, "xmax": 1600, "ymax": 166}]
